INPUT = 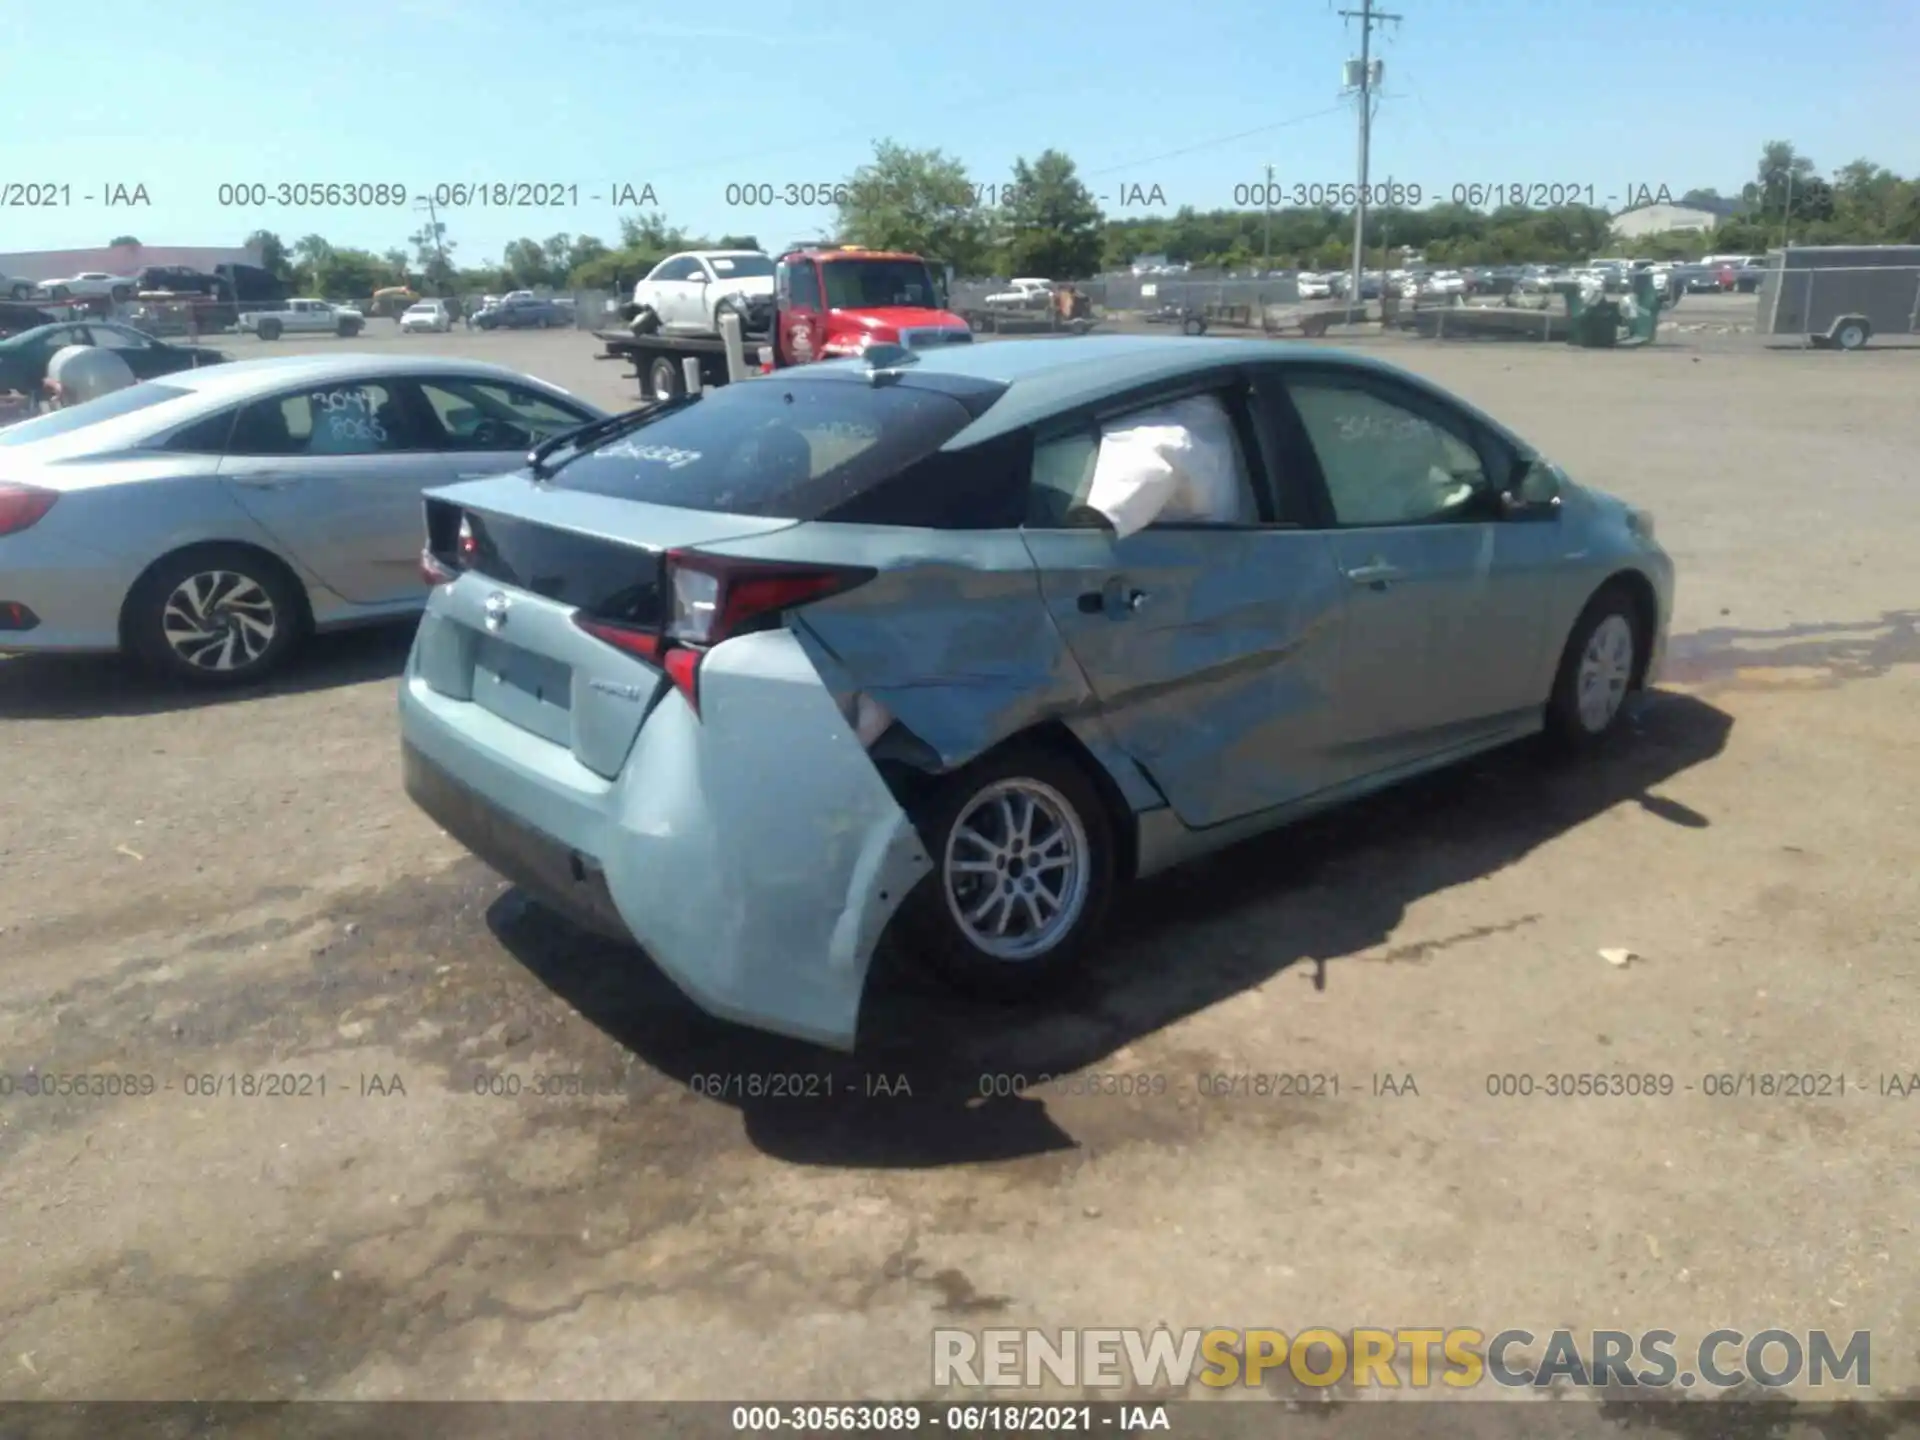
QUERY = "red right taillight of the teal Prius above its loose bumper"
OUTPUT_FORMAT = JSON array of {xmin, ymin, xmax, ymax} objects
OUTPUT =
[{"xmin": 574, "ymin": 549, "xmax": 874, "ymax": 714}]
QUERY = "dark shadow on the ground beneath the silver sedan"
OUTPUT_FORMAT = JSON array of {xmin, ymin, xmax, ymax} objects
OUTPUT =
[{"xmin": 0, "ymin": 620, "xmax": 415, "ymax": 720}]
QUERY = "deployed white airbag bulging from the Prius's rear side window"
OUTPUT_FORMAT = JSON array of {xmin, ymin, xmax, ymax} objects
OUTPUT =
[{"xmin": 1087, "ymin": 396, "xmax": 1254, "ymax": 540}]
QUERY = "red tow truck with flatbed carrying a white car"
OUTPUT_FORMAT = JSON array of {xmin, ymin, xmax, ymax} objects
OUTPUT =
[{"xmin": 595, "ymin": 246, "xmax": 973, "ymax": 399}]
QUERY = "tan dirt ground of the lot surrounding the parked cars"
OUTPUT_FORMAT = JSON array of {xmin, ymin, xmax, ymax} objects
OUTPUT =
[{"xmin": 0, "ymin": 315, "xmax": 1920, "ymax": 1400}]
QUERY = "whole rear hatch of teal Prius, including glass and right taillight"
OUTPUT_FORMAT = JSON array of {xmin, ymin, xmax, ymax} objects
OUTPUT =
[{"xmin": 415, "ymin": 372, "xmax": 1004, "ymax": 778}]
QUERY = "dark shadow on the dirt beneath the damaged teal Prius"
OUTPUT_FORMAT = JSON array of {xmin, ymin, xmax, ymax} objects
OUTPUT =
[{"xmin": 488, "ymin": 693, "xmax": 1732, "ymax": 1167}]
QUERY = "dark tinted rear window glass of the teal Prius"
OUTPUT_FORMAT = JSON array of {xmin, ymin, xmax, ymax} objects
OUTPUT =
[{"xmin": 553, "ymin": 376, "xmax": 972, "ymax": 520}]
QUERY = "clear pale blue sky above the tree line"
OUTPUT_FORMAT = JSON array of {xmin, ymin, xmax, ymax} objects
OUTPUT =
[{"xmin": 0, "ymin": 0, "xmax": 1920, "ymax": 265}]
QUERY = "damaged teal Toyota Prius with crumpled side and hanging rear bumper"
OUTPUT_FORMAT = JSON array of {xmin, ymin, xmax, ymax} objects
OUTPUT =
[{"xmin": 401, "ymin": 336, "xmax": 1672, "ymax": 1048}]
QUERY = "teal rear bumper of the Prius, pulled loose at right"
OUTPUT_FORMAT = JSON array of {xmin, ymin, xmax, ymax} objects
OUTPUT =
[{"xmin": 399, "ymin": 626, "xmax": 931, "ymax": 1050}]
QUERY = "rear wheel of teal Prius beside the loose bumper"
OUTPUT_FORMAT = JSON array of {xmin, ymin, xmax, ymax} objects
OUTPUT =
[{"xmin": 900, "ymin": 745, "xmax": 1117, "ymax": 1002}]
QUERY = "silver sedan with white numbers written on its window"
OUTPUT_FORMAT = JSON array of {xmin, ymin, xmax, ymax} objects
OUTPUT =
[{"xmin": 0, "ymin": 355, "xmax": 605, "ymax": 684}]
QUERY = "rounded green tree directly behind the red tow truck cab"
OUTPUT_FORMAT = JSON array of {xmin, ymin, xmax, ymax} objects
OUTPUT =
[{"xmin": 837, "ymin": 140, "xmax": 991, "ymax": 275}]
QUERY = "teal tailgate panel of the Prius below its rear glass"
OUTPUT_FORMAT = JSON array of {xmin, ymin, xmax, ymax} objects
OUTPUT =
[{"xmin": 415, "ymin": 474, "xmax": 793, "ymax": 778}]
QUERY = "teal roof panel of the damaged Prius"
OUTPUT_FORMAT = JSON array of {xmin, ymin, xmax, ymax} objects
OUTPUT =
[{"xmin": 802, "ymin": 334, "xmax": 1404, "ymax": 449}]
